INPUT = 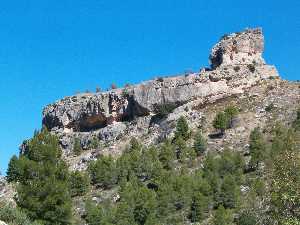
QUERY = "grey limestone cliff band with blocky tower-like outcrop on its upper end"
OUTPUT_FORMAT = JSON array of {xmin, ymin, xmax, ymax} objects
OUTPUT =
[{"xmin": 43, "ymin": 26, "xmax": 278, "ymax": 131}]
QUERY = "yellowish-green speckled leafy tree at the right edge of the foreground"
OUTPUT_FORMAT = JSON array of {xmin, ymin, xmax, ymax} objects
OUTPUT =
[{"xmin": 270, "ymin": 129, "xmax": 300, "ymax": 224}]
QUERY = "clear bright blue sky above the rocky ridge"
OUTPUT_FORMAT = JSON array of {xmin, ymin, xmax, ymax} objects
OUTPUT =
[{"xmin": 0, "ymin": 0, "xmax": 300, "ymax": 174}]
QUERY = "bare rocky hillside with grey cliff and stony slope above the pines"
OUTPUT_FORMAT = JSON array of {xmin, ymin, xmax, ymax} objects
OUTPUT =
[{"xmin": 0, "ymin": 28, "xmax": 300, "ymax": 225}]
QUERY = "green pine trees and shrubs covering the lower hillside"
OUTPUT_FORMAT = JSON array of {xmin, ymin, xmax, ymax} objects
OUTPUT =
[{"xmin": 0, "ymin": 107, "xmax": 300, "ymax": 225}]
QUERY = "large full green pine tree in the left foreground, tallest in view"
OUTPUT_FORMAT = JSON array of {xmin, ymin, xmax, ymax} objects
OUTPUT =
[{"xmin": 17, "ymin": 129, "xmax": 72, "ymax": 225}]
